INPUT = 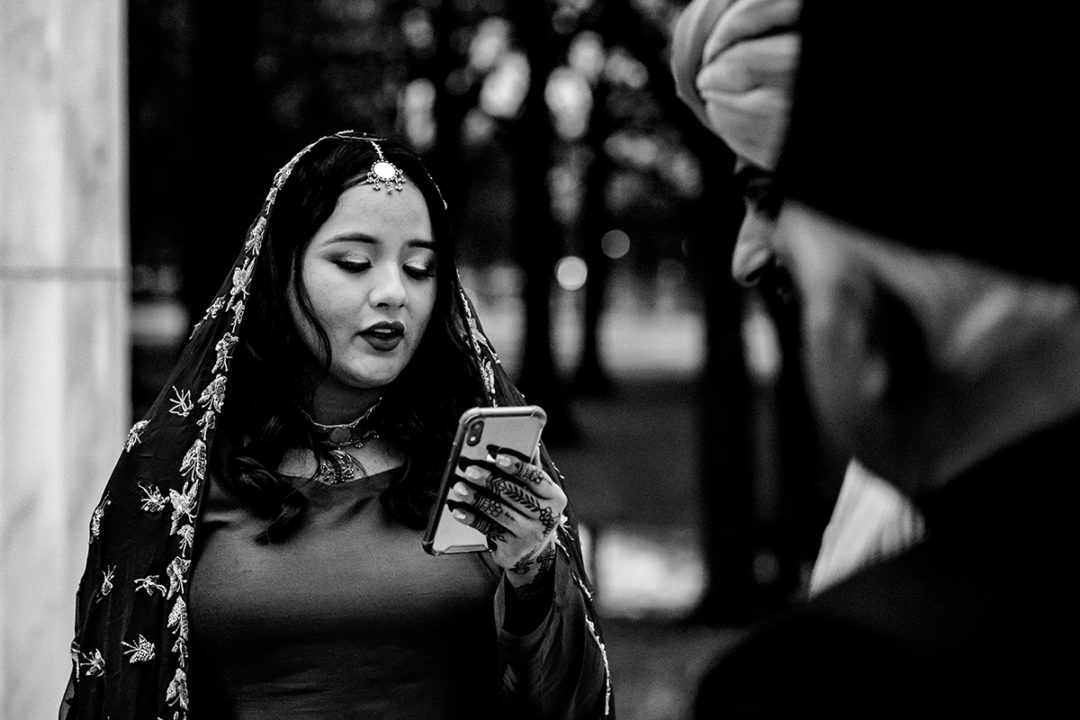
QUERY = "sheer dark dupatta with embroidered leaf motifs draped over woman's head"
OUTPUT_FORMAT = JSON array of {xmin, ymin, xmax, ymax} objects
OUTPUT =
[{"xmin": 59, "ymin": 132, "xmax": 611, "ymax": 720}]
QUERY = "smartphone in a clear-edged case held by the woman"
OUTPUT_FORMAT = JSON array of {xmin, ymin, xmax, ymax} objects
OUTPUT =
[{"xmin": 423, "ymin": 405, "xmax": 548, "ymax": 555}]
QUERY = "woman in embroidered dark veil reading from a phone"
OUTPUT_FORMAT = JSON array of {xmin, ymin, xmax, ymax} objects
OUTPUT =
[{"xmin": 60, "ymin": 133, "xmax": 613, "ymax": 720}]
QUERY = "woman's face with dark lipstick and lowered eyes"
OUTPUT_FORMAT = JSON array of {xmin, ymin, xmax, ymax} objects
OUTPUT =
[{"xmin": 289, "ymin": 177, "xmax": 436, "ymax": 395}]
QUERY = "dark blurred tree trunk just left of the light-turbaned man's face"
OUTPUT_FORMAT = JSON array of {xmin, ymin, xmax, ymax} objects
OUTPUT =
[{"xmin": 603, "ymin": 0, "xmax": 759, "ymax": 625}]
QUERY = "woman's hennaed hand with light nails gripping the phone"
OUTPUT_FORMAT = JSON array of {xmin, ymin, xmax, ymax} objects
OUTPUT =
[{"xmin": 449, "ymin": 452, "xmax": 566, "ymax": 595}]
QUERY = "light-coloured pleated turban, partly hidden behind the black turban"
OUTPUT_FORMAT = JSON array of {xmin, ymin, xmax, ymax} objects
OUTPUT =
[{"xmin": 672, "ymin": 0, "xmax": 800, "ymax": 171}]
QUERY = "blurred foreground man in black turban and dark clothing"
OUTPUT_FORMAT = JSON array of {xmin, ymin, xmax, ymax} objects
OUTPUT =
[{"xmin": 697, "ymin": 0, "xmax": 1080, "ymax": 718}]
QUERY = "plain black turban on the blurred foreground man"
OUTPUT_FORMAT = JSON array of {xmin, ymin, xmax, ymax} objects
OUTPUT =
[{"xmin": 778, "ymin": 0, "xmax": 1080, "ymax": 286}]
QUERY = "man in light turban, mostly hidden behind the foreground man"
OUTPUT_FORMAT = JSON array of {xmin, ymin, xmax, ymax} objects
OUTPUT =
[{"xmin": 672, "ymin": 0, "xmax": 922, "ymax": 594}]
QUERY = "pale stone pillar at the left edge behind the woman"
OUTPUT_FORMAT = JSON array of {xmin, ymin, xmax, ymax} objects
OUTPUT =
[{"xmin": 0, "ymin": 0, "xmax": 130, "ymax": 718}]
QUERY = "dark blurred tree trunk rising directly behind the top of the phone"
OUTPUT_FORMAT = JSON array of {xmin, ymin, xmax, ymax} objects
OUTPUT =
[{"xmin": 509, "ymin": 2, "xmax": 579, "ymax": 445}]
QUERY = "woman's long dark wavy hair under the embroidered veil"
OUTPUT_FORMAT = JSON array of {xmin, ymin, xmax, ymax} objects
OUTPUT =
[{"xmin": 221, "ymin": 135, "xmax": 483, "ymax": 542}]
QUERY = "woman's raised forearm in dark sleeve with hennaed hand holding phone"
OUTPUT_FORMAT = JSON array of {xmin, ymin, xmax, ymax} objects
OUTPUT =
[{"xmin": 449, "ymin": 454, "xmax": 615, "ymax": 720}]
